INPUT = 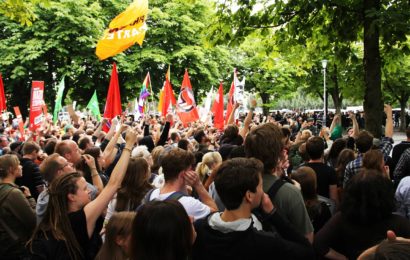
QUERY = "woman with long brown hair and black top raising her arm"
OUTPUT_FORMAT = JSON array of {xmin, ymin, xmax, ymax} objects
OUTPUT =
[{"xmin": 29, "ymin": 130, "xmax": 137, "ymax": 259}]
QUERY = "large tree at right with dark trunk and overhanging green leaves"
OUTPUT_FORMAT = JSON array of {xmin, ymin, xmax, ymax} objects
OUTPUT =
[{"xmin": 214, "ymin": 0, "xmax": 410, "ymax": 137}]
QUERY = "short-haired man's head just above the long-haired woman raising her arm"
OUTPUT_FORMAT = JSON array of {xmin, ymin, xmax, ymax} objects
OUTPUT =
[{"xmin": 40, "ymin": 153, "xmax": 75, "ymax": 183}]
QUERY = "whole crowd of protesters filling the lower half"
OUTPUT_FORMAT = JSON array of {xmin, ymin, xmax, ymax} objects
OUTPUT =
[{"xmin": 0, "ymin": 101, "xmax": 410, "ymax": 260}]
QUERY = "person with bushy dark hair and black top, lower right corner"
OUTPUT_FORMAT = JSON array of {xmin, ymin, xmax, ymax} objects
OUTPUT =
[{"xmin": 314, "ymin": 169, "xmax": 410, "ymax": 259}]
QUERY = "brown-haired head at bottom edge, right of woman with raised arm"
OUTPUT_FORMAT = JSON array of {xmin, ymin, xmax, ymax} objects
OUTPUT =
[{"xmin": 95, "ymin": 211, "xmax": 136, "ymax": 260}]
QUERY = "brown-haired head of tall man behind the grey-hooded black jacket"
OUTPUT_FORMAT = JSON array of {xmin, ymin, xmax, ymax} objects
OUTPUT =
[{"xmin": 245, "ymin": 123, "xmax": 284, "ymax": 174}]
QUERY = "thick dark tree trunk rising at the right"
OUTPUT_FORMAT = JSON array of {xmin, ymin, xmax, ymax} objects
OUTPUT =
[{"xmin": 363, "ymin": 0, "xmax": 383, "ymax": 138}]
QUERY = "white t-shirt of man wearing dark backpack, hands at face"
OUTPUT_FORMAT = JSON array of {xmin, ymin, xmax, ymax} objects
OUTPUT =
[{"xmin": 149, "ymin": 189, "xmax": 211, "ymax": 221}]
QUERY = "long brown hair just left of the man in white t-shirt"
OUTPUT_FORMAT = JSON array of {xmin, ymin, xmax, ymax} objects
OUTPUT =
[{"xmin": 115, "ymin": 157, "xmax": 152, "ymax": 211}]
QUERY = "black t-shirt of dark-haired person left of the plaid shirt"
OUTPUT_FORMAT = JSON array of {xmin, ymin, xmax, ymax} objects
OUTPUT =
[{"xmin": 305, "ymin": 163, "xmax": 337, "ymax": 198}]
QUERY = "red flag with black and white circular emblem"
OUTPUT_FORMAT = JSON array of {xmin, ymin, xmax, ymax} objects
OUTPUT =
[{"xmin": 177, "ymin": 70, "xmax": 199, "ymax": 125}]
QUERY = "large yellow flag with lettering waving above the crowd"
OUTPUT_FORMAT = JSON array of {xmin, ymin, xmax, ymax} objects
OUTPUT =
[{"xmin": 96, "ymin": 0, "xmax": 148, "ymax": 60}]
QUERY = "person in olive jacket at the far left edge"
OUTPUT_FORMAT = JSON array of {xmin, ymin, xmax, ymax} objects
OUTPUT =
[{"xmin": 0, "ymin": 154, "xmax": 36, "ymax": 259}]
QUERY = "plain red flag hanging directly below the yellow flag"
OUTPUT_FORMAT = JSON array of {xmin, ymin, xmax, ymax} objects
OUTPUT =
[{"xmin": 103, "ymin": 62, "xmax": 122, "ymax": 132}]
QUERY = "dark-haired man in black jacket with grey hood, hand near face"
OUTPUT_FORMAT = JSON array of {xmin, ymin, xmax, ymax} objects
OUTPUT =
[{"xmin": 192, "ymin": 158, "xmax": 314, "ymax": 260}]
